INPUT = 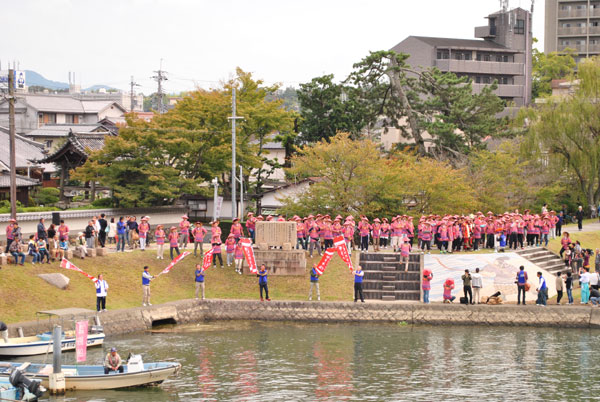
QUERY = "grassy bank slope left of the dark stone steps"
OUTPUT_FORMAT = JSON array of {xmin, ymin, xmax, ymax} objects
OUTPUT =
[{"xmin": 0, "ymin": 250, "xmax": 358, "ymax": 323}]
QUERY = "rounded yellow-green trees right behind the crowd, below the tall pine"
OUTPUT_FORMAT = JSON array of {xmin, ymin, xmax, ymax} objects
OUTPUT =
[{"xmin": 282, "ymin": 133, "xmax": 477, "ymax": 216}]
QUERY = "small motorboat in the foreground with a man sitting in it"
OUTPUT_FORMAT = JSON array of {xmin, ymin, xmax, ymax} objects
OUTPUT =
[{"xmin": 0, "ymin": 355, "xmax": 181, "ymax": 391}]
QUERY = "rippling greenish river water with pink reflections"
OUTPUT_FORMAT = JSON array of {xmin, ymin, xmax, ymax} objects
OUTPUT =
[{"xmin": 16, "ymin": 322, "xmax": 600, "ymax": 402}]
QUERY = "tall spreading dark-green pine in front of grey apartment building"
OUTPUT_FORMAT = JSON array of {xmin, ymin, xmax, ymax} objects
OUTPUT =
[{"xmin": 347, "ymin": 51, "xmax": 504, "ymax": 160}]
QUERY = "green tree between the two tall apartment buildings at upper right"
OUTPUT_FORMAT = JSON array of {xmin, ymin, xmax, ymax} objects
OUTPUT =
[{"xmin": 532, "ymin": 48, "xmax": 575, "ymax": 99}]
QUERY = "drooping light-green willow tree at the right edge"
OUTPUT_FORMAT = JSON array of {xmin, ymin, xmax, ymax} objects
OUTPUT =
[{"xmin": 516, "ymin": 58, "xmax": 600, "ymax": 212}]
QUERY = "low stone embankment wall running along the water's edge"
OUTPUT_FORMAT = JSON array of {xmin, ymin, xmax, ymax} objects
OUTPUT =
[{"xmin": 9, "ymin": 299, "xmax": 600, "ymax": 336}]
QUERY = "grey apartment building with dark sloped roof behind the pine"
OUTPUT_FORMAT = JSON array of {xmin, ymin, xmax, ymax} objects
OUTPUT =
[{"xmin": 392, "ymin": 7, "xmax": 532, "ymax": 106}]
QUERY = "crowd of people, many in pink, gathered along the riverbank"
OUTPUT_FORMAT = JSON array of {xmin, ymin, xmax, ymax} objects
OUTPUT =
[{"xmin": 5, "ymin": 206, "xmax": 600, "ymax": 311}]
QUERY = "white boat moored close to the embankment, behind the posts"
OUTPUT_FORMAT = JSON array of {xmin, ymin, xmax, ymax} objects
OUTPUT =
[{"xmin": 0, "ymin": 334, "xmax": 104, "ymax": 356}]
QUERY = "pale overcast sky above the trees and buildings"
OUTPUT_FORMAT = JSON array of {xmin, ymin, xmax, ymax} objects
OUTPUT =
[{"xmin": 0, "ymin": 0, "xmax": 544, "ymax": 94}]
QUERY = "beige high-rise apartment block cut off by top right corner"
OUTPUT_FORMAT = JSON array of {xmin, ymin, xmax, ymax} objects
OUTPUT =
[{"xmin": 544, "ymin": 0, "xmax": 600, "ymax": 63}]
